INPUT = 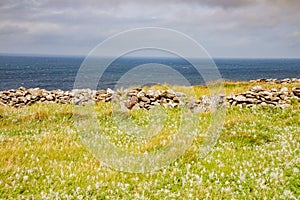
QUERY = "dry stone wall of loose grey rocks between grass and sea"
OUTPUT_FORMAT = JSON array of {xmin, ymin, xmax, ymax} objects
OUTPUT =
[{"xmin": 0, "ymin": 79, "xmax": 300, "ymax": 112}]
